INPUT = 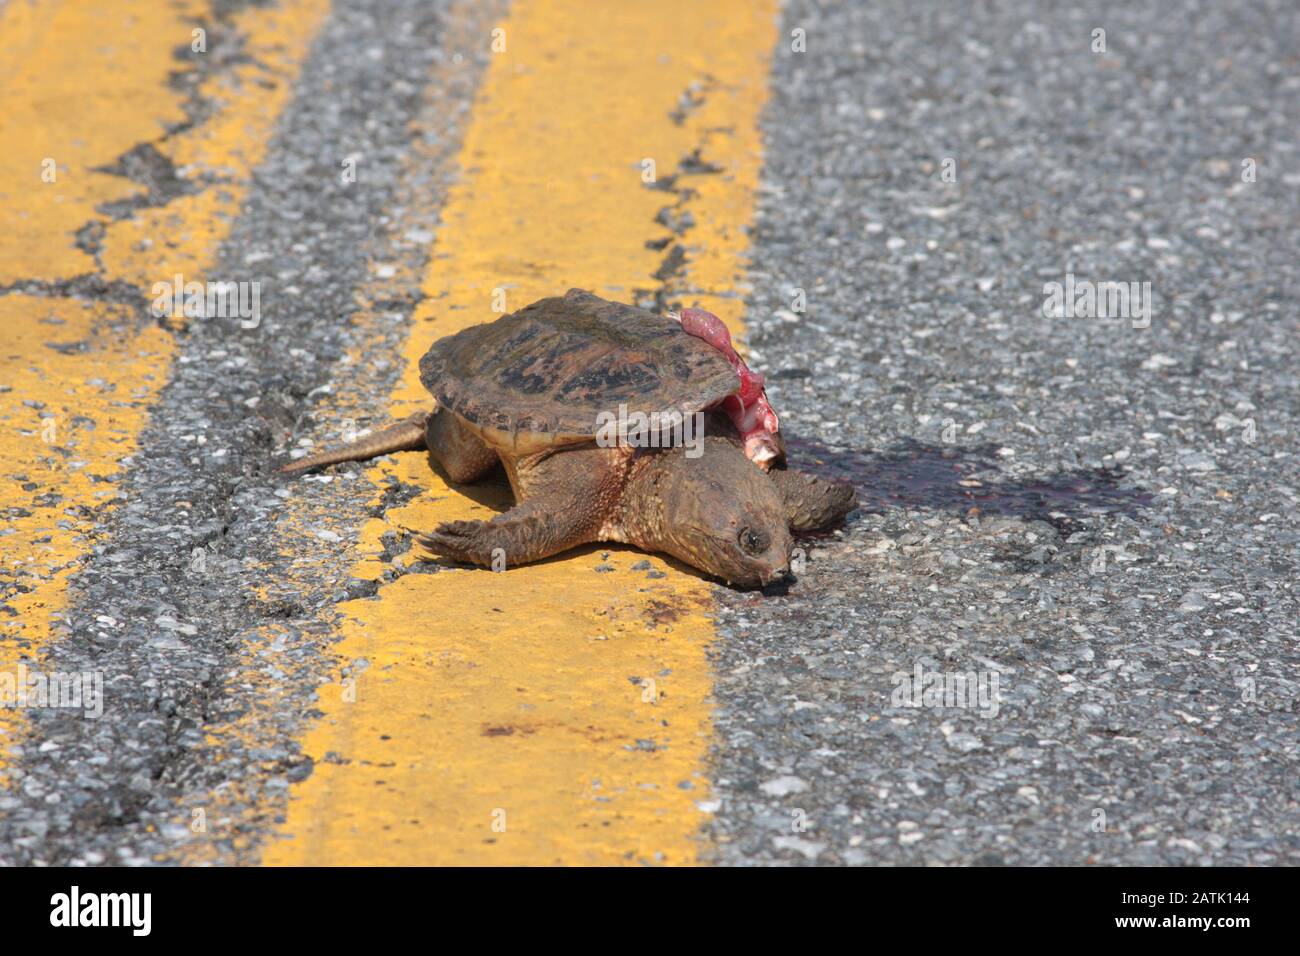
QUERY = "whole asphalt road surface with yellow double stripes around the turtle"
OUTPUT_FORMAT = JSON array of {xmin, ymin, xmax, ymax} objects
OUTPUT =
[{"xmin": 0, "ymin": 0, "xmax": 1300, "ymax": 865}]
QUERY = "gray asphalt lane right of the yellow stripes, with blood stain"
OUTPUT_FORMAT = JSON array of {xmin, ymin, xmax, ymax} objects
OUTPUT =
[{"xmin": 712, "ymin": 0, "xmax": 1300, "ymax": 865}]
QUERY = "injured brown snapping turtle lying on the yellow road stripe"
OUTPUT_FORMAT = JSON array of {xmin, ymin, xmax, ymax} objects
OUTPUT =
[{"xmin": 281, "ymin": 289, "xmax": 857, "ymax": 587}]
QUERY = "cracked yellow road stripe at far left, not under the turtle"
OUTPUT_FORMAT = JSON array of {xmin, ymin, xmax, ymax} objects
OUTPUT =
[{"xmin": 0, "ymin": 0, "xmax": 328, "ymax": 766}]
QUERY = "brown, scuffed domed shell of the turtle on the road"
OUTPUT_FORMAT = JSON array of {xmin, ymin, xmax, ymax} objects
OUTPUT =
[{"xmin": 420, "ymin": 289, "xmax": 740, "ymax": 454}]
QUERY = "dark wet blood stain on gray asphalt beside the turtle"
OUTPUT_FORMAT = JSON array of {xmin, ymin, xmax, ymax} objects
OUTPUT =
[{"xmin": 785, "ymin": 438, "xmax": 1152, "ymax": 536}]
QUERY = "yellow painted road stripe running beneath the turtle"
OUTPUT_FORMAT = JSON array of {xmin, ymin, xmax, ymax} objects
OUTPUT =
[{"xmin": 264, "ymin": 0, "xmax": 776, "ymax": 864}]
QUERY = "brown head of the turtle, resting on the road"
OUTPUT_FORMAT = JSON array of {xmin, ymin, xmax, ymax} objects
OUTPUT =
[{"xmin": 625, "ymin": 437, "xmax": 794, "ymax": 588}]
